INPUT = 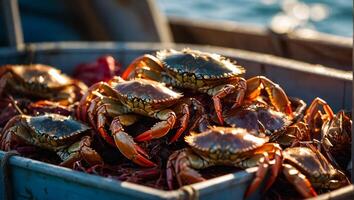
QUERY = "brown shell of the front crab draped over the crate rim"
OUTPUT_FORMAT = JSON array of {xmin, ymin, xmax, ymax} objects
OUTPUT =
[{"xmin": 185, "ymin": 127, "xmax": 269, "ymax": 163}]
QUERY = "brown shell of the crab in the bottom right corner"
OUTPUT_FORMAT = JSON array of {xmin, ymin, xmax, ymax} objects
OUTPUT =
[{"xmin": 283, "ymin": 147, "xmax": 335, "ymax": 179}]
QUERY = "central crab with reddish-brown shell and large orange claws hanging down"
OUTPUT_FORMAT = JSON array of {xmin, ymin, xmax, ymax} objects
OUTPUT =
[{"xmin": 77, "ymin": 77, "xmax": 205, "ymax": 167}]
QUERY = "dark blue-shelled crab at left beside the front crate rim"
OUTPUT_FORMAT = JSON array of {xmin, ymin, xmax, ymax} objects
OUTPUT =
[{"xmin": 0, "ymin": 114, "xmax": 102, "ymax": 168}]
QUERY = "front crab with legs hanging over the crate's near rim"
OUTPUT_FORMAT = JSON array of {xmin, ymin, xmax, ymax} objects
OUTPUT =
[{"xmin": 166, "ymin": 126, "xmax": 282, "ymax": 197}]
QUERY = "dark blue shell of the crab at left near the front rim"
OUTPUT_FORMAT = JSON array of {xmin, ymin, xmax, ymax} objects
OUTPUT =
[{"xmin": 24, "ymin": 114, "xmax": 90, "ymax": 150}]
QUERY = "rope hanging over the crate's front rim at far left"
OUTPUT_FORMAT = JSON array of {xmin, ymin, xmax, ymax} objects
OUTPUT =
[{"xmin": 1, "ymin": 151, "xmax": 19, "ymax": 200}]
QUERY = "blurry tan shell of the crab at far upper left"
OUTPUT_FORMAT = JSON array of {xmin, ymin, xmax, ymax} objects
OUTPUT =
[{"xmin": 4, "ymin": 64, "xmax": 72, "ymax": 88}]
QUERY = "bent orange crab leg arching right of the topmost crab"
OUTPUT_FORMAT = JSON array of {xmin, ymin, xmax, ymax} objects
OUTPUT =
[{"xmin": 245, "ymin": 76, "xmax": 293, "ymax": 116}]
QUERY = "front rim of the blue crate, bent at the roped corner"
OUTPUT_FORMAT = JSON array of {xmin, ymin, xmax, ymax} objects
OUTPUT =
[{"xmin": 0, "ymin": 150, "xmax": 258, "ymax": 199}]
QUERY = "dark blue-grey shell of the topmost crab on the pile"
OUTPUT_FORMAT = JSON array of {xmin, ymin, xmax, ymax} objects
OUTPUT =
[{"xmin": 156, "ymin": 49, "xmax": 245, "ymax": 87}]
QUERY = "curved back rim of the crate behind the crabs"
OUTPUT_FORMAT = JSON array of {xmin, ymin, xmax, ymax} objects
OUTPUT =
[{"xmin": 0, "ymin": 41, "xmax": 353, "ymax": 81}]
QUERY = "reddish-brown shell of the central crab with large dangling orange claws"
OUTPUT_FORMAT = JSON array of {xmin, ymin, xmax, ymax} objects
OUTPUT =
[{"xmin": 113, "ymin": 78, "xmax": 183, "ymax": 114}]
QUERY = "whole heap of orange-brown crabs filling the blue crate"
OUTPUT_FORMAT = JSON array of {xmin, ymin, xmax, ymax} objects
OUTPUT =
[{"xmin": 0, "ymin": 49, "xmax": 352, "ymax": 198}]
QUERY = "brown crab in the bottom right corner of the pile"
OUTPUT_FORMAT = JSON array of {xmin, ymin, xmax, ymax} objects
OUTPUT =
[{"xmin": 282, "ymin": 143, "xmax": 350, "ymax": 198}]
